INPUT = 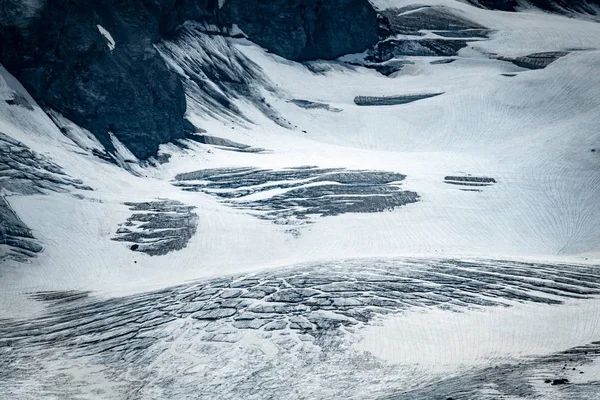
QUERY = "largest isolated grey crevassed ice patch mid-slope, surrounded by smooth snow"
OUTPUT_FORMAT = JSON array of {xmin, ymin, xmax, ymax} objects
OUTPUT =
[{"xmin": 175, "ymin": 166, "xmax": 419, "ymax": 228}]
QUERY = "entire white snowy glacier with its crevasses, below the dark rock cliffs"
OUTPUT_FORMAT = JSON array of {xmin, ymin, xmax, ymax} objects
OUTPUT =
[{"xmin": 0, "ymin": 0, "xmax": 600, "ymax": 400}]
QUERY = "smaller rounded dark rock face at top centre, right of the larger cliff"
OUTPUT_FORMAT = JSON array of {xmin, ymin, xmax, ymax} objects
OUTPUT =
[{"xmin": 219, "ymin": 0, "xmax": 378, "ymax": 61}]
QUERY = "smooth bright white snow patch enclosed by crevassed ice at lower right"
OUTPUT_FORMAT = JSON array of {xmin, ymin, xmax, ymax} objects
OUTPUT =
[{"xmin": 356, "ymin": 300, "xmax": 600, "ymax": 373}]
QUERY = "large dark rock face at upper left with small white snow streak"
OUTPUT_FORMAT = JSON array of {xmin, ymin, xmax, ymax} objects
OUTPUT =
[{"xmin": 0, "ymin": 0, "xmax": 204, "ymax": 158}]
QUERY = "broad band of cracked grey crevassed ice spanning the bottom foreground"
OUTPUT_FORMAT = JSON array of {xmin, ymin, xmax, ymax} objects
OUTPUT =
[{"xmin": 0, "ymin": 259, "xmax": 600, "ymax": 400}]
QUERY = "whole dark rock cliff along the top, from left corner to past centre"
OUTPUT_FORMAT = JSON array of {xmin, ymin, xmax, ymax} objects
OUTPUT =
[{"xmin": 0, "ymin": 0, "xmax": 377, "ymax": 158}]
